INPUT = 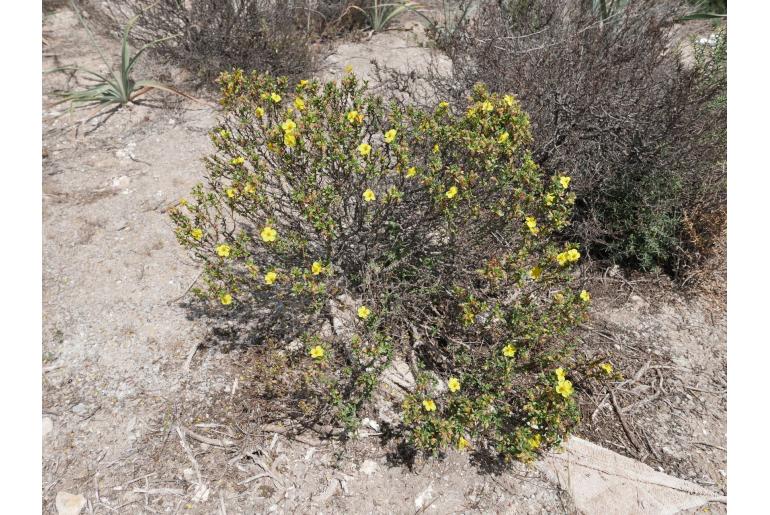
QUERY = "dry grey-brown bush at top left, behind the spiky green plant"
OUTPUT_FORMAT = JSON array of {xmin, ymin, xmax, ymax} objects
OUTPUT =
[{"xmin": 92, "ymin": 0, "xmax": 358, "ymax": 84}]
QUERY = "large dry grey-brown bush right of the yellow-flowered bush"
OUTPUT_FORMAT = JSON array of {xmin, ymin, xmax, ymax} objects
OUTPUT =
[{"xmin": 388, "ymin": 0, "xmax": 726, "ymax": 274}]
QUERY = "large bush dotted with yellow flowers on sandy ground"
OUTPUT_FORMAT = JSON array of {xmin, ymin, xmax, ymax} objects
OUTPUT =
[{"xmin": 171, "ymin": 71, "xmax": 590, "ymax": 459}]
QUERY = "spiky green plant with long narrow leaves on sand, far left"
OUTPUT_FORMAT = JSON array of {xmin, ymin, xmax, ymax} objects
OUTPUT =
[{"xmin": 51, "ymin": 2, "xmax": 197, "ymax": 107}]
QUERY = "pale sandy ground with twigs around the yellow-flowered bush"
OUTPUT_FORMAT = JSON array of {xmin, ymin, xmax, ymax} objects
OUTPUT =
[{"xmin": 42, "ymin": 5, "xmax": 726, "ymax": 514}]
